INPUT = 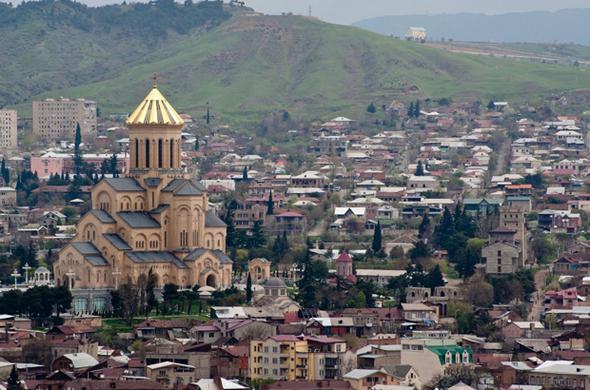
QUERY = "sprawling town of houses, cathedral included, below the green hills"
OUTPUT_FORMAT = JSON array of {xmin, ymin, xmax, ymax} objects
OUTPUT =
[{"xmin": 0, "ymin": 81, "xmax": 590, "ymax": 390}]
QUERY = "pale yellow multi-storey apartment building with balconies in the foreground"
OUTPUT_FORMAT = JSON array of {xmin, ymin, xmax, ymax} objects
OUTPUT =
[{"xmin": 249, "ymin": 335, "xmax": 346, "ymax": 381}]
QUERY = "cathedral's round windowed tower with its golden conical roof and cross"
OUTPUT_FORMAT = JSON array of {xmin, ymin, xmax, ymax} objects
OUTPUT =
[{"xmin": 126, "ymin": 77, "xmax": 184, "ymax": 188}]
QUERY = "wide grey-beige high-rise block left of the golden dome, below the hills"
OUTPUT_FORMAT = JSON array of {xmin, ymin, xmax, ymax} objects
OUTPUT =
[{"xmin": 33, "ymin": 98, "xmax": 96, "ymax": 141}]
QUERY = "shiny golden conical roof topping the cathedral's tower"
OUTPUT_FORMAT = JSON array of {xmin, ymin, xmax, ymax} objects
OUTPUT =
[{"xmin": 126, "ymin": 85, "xmax": 184, "ymax": 126}]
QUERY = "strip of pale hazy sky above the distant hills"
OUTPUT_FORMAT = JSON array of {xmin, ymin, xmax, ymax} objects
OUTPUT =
[{"xmin": 245, "ymin": 0, "xmax": 590, "ymax": 24}]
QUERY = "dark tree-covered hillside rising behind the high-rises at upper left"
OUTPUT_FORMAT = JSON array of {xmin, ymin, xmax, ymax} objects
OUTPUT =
[{"xmin": 0, "ymin": 0, "xmax": 230, "ymax": 107}]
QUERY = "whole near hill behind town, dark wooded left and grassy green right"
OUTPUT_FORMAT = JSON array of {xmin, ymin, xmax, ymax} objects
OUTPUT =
[{"xmin": 0, "ymin": 0, "xmax": 590, "ymax": 122}]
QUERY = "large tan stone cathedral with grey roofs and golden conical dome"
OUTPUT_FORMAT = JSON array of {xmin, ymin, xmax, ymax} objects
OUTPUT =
[{"xmin": 53, "ymin": 85, "xmax": 232, "ymax": 311}]
